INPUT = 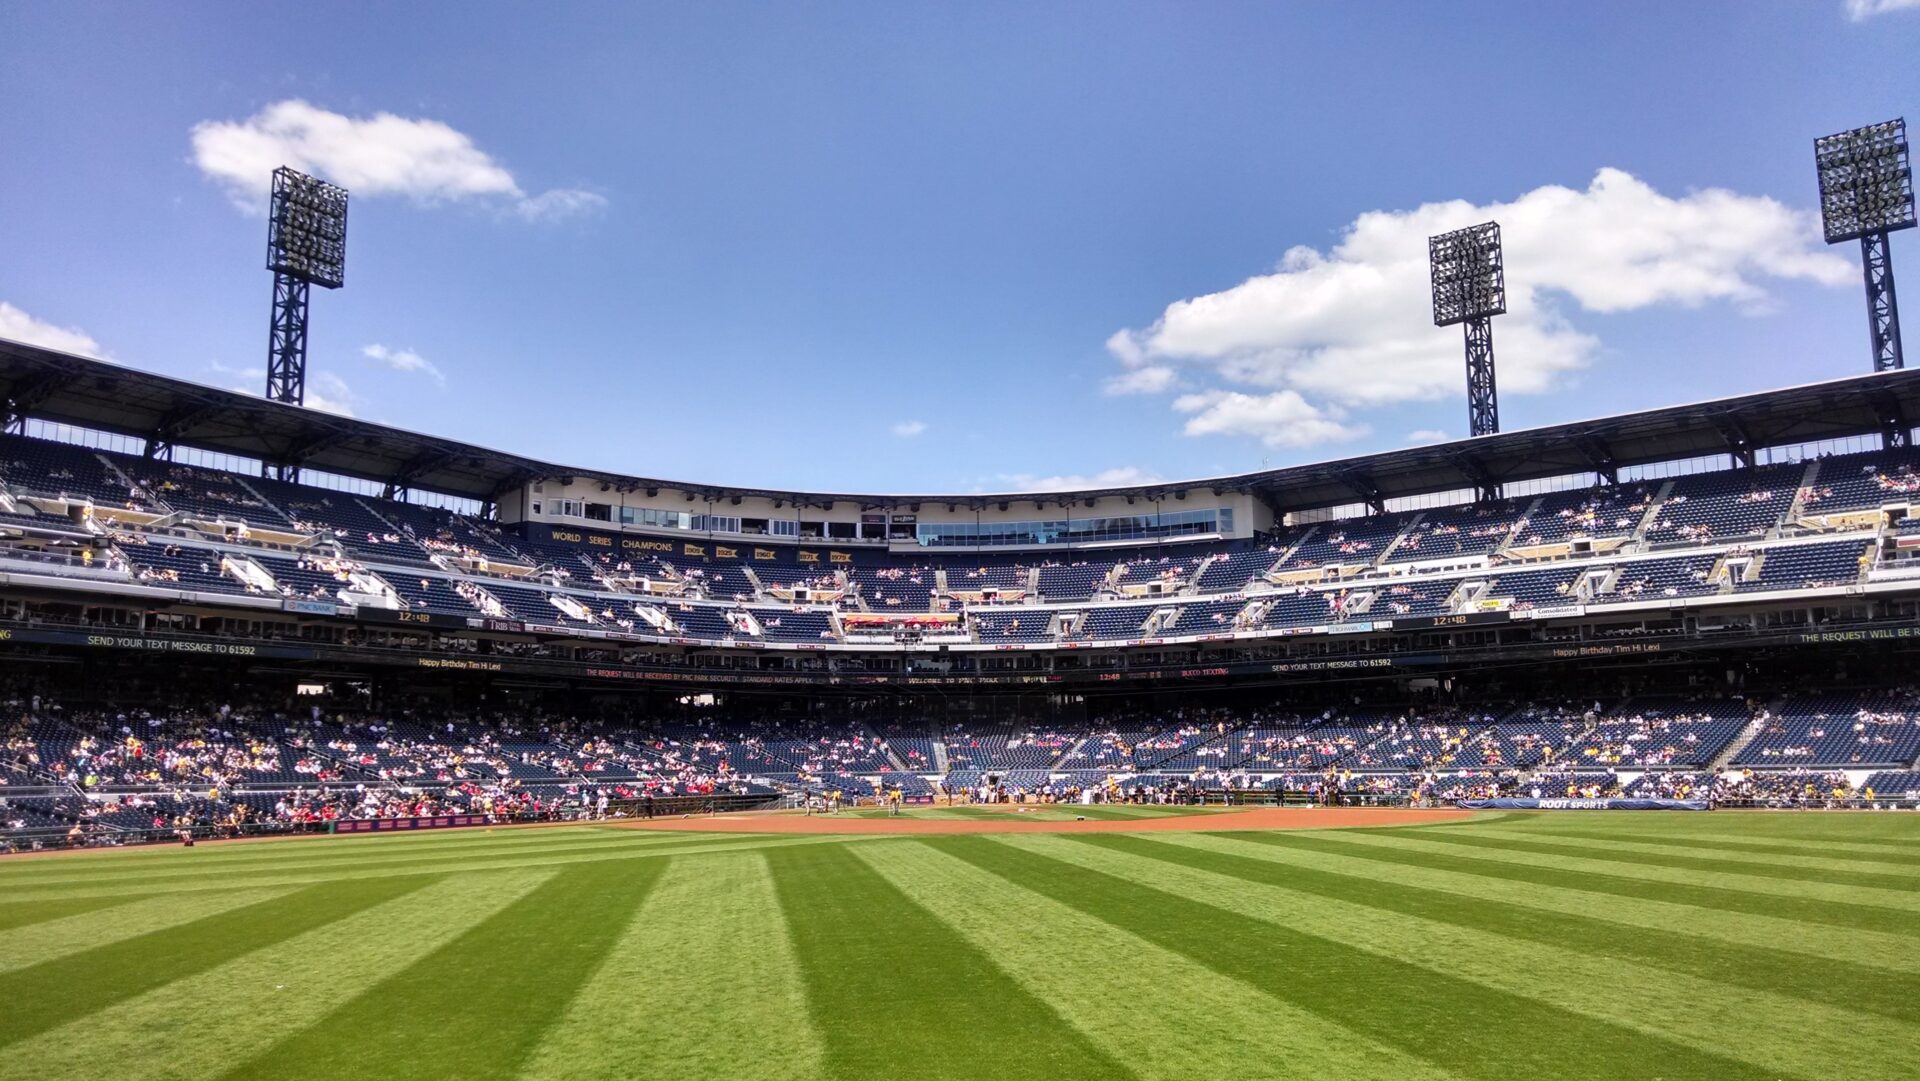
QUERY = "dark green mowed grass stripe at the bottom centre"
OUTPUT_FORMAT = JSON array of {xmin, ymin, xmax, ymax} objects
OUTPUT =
[{"xmin": 766, "ymin": 841, "xmax": 1131, "ymax": 1081}]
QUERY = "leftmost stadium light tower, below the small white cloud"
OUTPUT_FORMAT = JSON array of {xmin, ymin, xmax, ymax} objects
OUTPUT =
[{"xmin": 267, "ymin": 165, "xmax": 348, "ymax": 405}]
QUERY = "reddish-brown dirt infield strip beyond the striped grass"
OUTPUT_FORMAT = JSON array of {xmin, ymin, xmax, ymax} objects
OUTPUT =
[{"xmin": 620, "ymin": 805, "xmax": 1475, "ymax": 833}]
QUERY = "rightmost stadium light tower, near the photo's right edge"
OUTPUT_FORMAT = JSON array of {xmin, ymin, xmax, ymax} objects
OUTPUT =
[{"xmin": 1812, "ymin": 119, "xmax": 1914, "ymax": 372}]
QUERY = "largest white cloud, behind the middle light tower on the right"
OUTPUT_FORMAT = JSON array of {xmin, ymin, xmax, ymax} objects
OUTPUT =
[{"xmin": 1108, "ymin": 169, "xmax": 1857, "ymax": 445}]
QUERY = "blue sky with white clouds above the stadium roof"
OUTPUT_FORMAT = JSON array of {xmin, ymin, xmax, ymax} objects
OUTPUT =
[{"xmin": 0, "ymin": 0, "xmax": 1920, "ymax": 492}]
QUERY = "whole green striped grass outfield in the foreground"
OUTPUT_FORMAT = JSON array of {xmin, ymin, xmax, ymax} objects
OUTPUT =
[{"xmin": 0, "ymin": 812, "xmax": 1920, "ymax": 1081}]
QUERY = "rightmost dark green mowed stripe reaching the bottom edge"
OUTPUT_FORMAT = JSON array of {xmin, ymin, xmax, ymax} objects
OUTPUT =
[{"xmin": 944, "ymin": 837, "xmax": 1780, "ymax": 1081}]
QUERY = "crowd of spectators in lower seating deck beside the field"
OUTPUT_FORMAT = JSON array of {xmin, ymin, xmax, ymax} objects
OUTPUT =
[{"xmin": 0, "ymin": 691, "xmax": 1912, "ymax": 856}]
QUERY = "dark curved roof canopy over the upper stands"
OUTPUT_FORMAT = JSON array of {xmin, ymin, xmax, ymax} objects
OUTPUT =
[{"xmin": 0, "ymin": 340, "xmax": 1920, "ymax": 511}]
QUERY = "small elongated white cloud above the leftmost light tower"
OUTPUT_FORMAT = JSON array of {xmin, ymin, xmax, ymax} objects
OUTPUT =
[{"xmin": 192, "ymin": 100, "xmax": 607, "ymax": 221}]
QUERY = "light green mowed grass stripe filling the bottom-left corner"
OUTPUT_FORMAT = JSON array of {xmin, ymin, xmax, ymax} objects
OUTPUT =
[{"xmin": 0, "ymin": 872, "xmax": 551, "ymax": 1081}]
